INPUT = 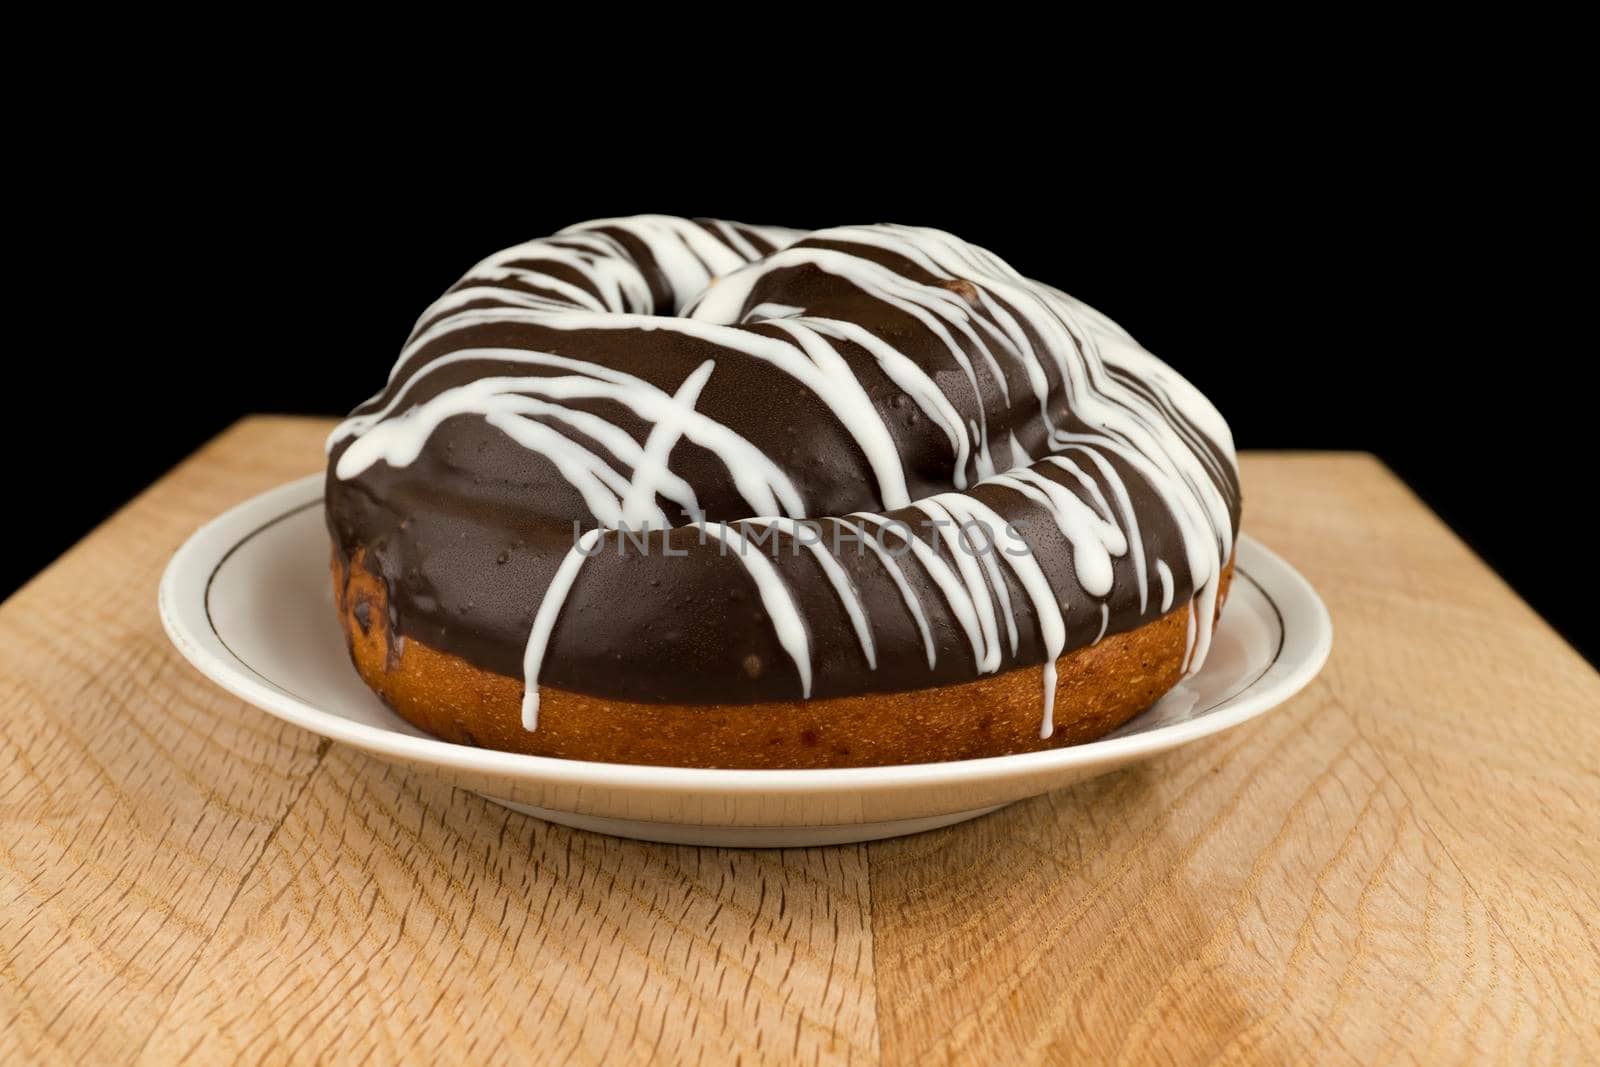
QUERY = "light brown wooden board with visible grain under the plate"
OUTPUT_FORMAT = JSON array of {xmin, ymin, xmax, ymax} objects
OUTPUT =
[{"xmin": 0, "ymin": 418, "xmax": 1600, "ymax": 1064}]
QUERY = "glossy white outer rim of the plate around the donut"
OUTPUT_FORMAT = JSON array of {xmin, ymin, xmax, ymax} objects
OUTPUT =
[{"xmin": 157, "ymin": 472, "xmax": 1333, "ymax": 795}]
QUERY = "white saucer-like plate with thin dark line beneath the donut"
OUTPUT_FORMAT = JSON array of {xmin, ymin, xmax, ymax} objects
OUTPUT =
[{"xmin": 160, "ymin": 475, "xmax": 1333, "ymax": 846}]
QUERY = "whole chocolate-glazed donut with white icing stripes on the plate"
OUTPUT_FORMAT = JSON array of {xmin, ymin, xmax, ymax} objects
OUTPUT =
[{"xmin": 326, "ymin": 216, "xmax": 1240, "ymax": 768}]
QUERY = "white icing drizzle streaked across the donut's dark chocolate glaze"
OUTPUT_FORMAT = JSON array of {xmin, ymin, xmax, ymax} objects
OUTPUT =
[{"xmin": 328, "ymin": 216, "xmax": 1235, "ymax": 737}]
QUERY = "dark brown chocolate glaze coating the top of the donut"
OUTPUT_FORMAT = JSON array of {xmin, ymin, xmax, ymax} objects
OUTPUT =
[{"xmin": 326, "ymin": 216, "xmax": 1240, "ymax": 704}]
